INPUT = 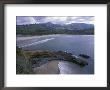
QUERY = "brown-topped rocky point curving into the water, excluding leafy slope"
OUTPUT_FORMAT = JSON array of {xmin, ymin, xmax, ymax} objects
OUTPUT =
[{"xmin": 25, "ymin": 51, "xmax": 88, "ymax": 67}]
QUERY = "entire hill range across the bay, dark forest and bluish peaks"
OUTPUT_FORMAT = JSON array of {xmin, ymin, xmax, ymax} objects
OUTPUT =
[{"xmin": 16, "ymin": 22, "xmax": 94, "ymax": 35}]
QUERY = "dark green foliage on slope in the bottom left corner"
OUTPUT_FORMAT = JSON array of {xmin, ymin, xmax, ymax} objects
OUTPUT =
[{"xmin": 16, "ymin": 46, "xmax": 33, "ymax": 74}]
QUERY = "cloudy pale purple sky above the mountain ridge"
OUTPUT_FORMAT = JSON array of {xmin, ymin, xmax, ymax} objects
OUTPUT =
[{"xmin": 16, "ymin": 16, "xmax": 94, "ymax": 25}]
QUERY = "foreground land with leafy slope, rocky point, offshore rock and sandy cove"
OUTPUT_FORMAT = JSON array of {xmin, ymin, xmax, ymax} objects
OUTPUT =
[{"xmin": 16, "ymin": 47, "xmax": 90, "ymax": 74}]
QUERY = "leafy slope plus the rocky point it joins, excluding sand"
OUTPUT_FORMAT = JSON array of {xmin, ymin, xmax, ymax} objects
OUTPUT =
[{"xmin": 16, "ymin": 47, "xmax": 88, "ymax": 74}]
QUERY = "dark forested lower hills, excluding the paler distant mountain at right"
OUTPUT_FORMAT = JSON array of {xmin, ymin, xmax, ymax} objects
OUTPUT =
[{"xmin": 16, "ymin": 24, "xmax": 94, "ymax": 35}]
